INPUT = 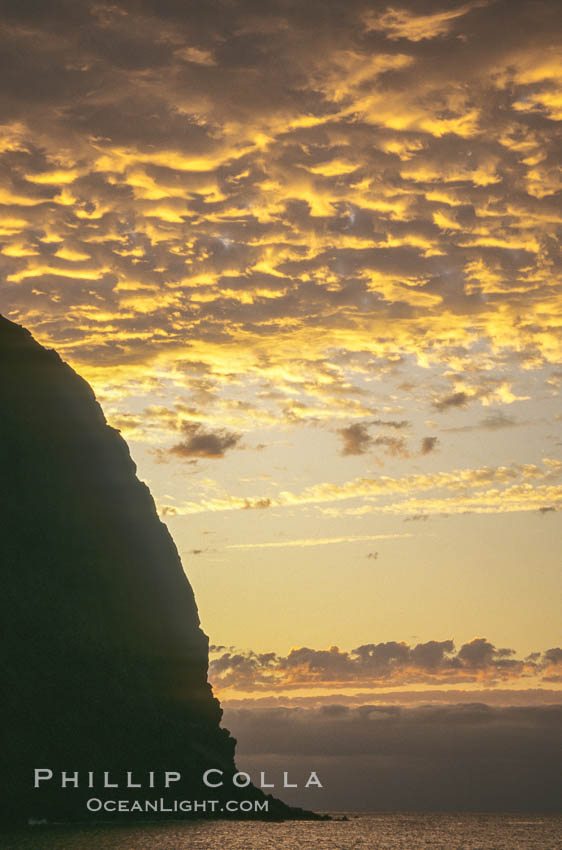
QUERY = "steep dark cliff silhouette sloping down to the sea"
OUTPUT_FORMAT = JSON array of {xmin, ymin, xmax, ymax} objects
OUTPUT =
[{"xmin": 0, "ymin": 317, "xmax": 316, "ymax": 820}]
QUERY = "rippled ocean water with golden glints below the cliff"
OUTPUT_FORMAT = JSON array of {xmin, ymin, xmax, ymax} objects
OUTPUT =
[{"xmin": 0, "ymin": 813, "xmax": 562, "ymax": 850}]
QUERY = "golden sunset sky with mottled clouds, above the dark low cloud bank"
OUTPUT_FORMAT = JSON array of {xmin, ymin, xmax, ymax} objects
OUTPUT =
[{"xmin": 0, "ymin": 0, "xmax": 562, "ymax": 716}]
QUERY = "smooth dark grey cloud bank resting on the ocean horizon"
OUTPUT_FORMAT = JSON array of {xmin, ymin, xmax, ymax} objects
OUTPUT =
[{"xmin": 225, "ymin": 702, "xmax": 562, "ymax": 812}]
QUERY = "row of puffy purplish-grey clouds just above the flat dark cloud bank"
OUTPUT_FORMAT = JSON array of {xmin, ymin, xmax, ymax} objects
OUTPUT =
[{"xmin": 209, "ymin": 638, "xmax": 562, "ymax": 694}]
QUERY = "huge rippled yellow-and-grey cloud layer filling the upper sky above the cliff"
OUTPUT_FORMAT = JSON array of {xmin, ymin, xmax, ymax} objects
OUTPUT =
[{"xmin": 0, "ymin": 0, "xmax": 561, "ymax": 430}]
